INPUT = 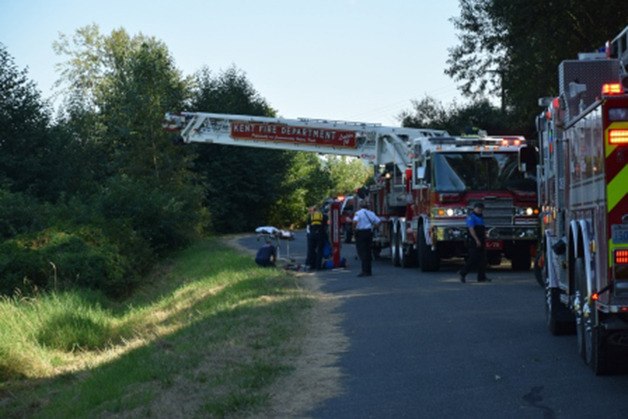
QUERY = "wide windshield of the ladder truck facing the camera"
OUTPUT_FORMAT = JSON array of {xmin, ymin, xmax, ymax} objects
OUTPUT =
[{"xmin": 433, "ymin": 152, "xmax": 536, "ymax": 192}]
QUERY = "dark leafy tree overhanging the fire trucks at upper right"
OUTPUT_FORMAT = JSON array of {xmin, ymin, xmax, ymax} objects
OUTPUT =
[{"xmin": 445, "ymin": 0, "xmax": 626, "ymax": 130}]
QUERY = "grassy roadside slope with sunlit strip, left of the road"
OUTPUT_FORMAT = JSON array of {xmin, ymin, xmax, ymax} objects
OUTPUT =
[{"xmin": 0, "ymin": 240, "xmax": 311, "ymax": 417}]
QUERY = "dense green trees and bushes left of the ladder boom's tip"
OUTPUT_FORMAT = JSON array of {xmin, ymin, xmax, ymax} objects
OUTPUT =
[{"xmin": 0, "ymin": 26, "xmax": 206, "ymax": 295}]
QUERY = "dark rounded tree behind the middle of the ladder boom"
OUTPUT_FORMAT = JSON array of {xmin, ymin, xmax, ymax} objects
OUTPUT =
[{"xmin": 191, "ymin": 67, "xmax": 296, "ymax": 232}]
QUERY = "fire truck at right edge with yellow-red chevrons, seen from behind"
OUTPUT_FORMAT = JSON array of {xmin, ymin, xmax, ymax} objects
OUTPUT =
[{"xmin": 536, "ymin": 27, "xmax": 628, "ymax": 374}]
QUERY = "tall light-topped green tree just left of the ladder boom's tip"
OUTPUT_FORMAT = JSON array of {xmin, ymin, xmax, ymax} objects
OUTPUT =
[{"xmin": 56, "ymin": 25, "xmax": 204, "ymax": 253}]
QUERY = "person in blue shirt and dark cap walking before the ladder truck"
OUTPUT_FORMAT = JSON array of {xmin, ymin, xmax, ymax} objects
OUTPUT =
[{"xmin": 458, "ymin": 202, "xmax": 490, "ymax": 283}]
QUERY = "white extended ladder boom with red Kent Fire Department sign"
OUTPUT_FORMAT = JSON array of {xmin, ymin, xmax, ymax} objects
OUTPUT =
[{"xmin": 166, "ymin": 112, "xmax": 447, "ymax": 170}]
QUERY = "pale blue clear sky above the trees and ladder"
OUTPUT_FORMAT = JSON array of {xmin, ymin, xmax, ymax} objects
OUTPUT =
[{"xmin": 0, "ymin": 0, "xmax": 460, "ymax": 126}]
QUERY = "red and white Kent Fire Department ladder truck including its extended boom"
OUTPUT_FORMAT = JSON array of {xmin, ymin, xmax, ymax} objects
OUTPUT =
[{"xmin": 166, "ymin": 112, "xmax": 538, "ymax": 271}]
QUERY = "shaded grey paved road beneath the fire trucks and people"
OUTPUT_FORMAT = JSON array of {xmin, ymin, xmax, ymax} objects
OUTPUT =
[{"xmin": 241, "ymin": 234, "xmax": 628, "ymax": 418}]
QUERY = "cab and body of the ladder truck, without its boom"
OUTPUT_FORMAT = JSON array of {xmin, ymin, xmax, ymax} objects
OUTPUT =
[{"xmin": 369, "ymin": 134, "xmax": 538, "ymax": 272}]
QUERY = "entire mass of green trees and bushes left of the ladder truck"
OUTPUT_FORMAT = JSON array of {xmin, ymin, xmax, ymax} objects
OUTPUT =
[{"xmin": 0, "ymin": 25, "xmax": 368, "ymax": 296}]
